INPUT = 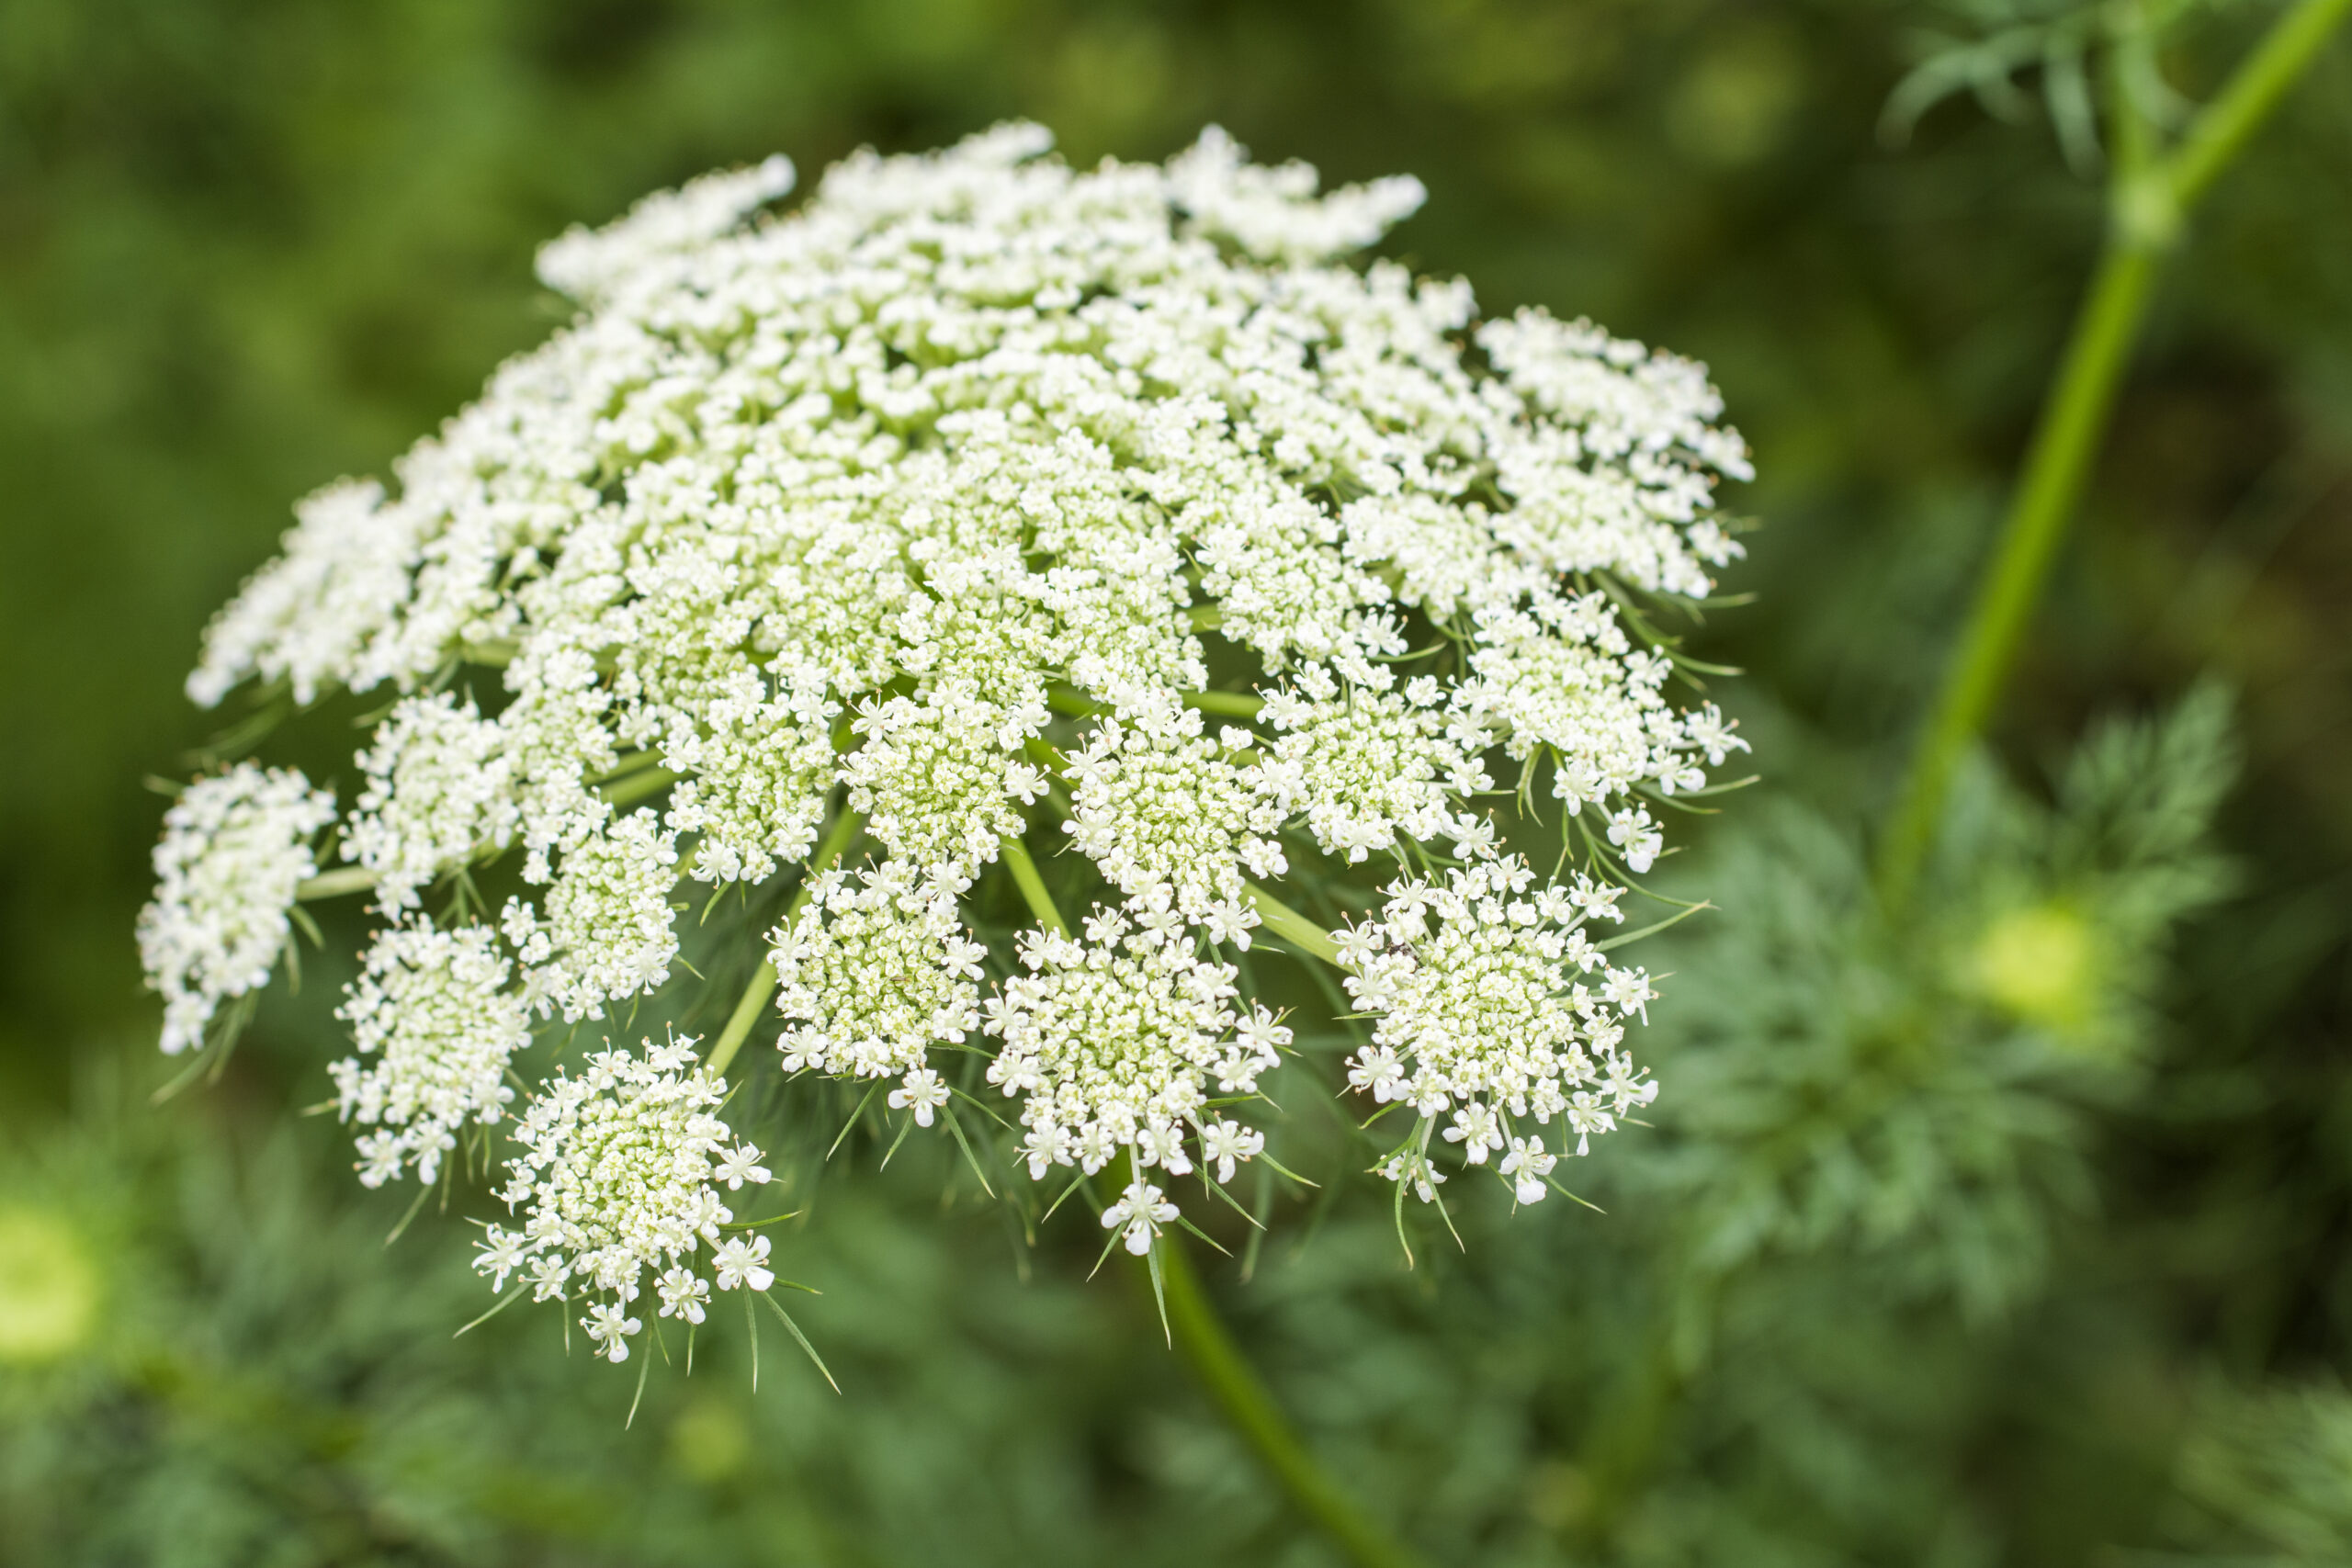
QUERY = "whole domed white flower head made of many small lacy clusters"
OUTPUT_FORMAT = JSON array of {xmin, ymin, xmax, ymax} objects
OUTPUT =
[{"xmin": 141, "ymin": 125, "xmax": 1747, "ymax": 1349}]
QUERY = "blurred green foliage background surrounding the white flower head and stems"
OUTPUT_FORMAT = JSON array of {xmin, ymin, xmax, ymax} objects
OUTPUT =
[{"xmin": 0, "ymin": 0, "xmax": 2352, "ymax": 1565}]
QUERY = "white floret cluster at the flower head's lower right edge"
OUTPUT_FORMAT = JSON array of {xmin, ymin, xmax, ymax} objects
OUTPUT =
[{"xmin": 1336, "ymin": 856, "xmax": 1658, "ymax": 1203}]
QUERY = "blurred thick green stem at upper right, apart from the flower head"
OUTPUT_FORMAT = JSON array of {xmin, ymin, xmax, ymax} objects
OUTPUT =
[{"xmin": 1877, "ymin": 0, "xmax": 2352, "ymax": 908}]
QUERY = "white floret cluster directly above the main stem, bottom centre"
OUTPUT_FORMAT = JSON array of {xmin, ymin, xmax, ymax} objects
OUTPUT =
[{"xmin": 986, "ymin": 907, "xmax": 1291, "ymax": 1213}]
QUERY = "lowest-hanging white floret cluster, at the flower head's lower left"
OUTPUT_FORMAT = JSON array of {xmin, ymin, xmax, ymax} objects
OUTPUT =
[{"xmin": 475, "ymin": 1039, "xmax": 774, "ymax": 1361}]
